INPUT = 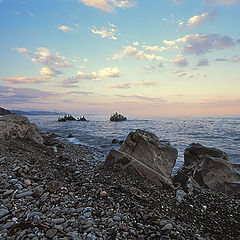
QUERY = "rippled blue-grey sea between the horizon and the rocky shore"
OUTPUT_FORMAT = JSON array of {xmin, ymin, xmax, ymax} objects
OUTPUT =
[{"xmin": 28, "ymin": 115, "xmax": 240, "ymax": 170}]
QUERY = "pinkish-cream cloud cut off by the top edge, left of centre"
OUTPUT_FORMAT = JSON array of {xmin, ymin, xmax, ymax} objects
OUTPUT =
[{"xmin": 78, "ymin": 0, "xmax": 137, "ymax": 12}]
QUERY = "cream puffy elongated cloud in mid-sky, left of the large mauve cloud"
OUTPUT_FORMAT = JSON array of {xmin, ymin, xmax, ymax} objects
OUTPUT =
[{"xmin": 112, "ymin": 46, "xmax": 165, "ymax": 61}]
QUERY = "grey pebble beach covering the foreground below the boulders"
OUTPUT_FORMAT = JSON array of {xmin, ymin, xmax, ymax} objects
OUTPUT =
[{"xmin": 0, "ymin": 134, "xmax": 240, "ymax": 240}]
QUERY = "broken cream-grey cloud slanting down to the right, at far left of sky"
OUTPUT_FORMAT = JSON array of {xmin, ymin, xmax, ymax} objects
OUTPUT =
[{"xmin": 16, "ymin": 47, "xmax": 71, "ymax": 69}]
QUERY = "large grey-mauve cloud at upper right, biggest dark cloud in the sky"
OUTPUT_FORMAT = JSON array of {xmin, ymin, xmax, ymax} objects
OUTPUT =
[{"xmin": 163, "ymin": 34, "xmax": 236, "ymax": 55}]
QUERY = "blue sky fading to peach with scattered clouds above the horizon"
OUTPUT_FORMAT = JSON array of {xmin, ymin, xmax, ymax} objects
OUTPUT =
[{"xmin": 0, "ymin": 0, "xmax": 240, "ymax": 116}]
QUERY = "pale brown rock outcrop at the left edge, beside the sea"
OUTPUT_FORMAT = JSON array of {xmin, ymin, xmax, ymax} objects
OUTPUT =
[{"xmin": 0, "ymin": 114, "xmax": 43, "ymax": 144}]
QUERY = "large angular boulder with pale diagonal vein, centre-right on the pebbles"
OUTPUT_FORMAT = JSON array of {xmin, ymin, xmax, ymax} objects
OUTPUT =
[{"xmin": 105, "ymin": 129, "xmax": 178, "ymax": 186}]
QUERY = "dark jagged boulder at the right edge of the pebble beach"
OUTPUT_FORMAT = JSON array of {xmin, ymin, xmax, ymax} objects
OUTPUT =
[{"xmin": 174, "ymin": 143, "xmax": 240, "ymax": 195}]
